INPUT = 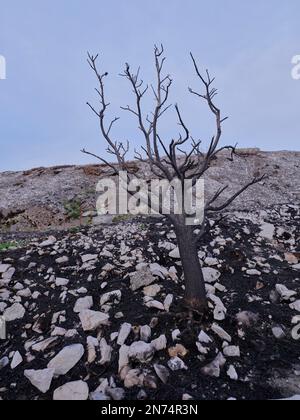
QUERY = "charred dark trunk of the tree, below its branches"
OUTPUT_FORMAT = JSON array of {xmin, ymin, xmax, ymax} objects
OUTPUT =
[{"xmin": 175, "ymin": 224, "xmax": 208, "ymax": 313}]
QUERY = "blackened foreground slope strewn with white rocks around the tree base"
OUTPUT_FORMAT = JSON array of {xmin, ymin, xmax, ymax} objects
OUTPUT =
[{"xmin": 0, "ymin": 204, "xmax": 300, "ymax": 401}]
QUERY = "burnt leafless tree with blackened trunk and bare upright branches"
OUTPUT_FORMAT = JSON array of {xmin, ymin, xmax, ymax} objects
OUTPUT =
[{"xmin": 82, "ymin": 46, "xmax": 264, "ymax": 313}]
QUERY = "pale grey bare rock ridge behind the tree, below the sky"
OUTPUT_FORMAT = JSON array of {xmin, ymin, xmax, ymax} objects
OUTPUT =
[{"xmin": 0, "ymin": 149, "xmax": 300, "ymax": 232}]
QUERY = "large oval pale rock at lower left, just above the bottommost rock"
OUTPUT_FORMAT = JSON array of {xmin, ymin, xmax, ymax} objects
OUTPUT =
[{"xmin": 48, "ymin": 344, "xmax": 84, "ymax": 376}]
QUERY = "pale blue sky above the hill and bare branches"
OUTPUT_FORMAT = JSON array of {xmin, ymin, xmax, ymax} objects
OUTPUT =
[{"xmin": 0, "ymin": 0, "xmax": 300, "ymax": 171}]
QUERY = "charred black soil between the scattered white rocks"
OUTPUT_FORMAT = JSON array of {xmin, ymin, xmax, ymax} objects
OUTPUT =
[{"xmin": 0, "ymin": 206, "xmax": 300, "ymax": 400}]
